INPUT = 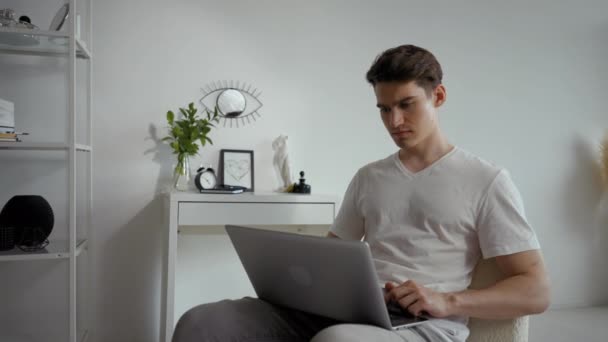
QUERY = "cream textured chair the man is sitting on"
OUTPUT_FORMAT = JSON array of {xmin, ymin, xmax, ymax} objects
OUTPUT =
[{"xmin": 467, "ymin": 258, "xmax": 528, "ymax": 342}]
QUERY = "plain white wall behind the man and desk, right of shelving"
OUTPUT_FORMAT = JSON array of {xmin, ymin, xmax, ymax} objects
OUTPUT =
[{"xmin": 0, "ymin": 0, "xmax": 608, "ymax": 342}]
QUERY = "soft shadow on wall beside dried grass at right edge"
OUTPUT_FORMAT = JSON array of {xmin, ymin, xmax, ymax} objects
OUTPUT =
[{"xmin": 563, "ymin": 136, "xmax": 608, "ymax": 304}]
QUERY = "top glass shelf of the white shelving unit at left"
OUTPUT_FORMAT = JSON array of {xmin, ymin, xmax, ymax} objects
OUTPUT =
[{"xmin": 0, "ymin": 28, "xmax": 92, "ymax": 59}]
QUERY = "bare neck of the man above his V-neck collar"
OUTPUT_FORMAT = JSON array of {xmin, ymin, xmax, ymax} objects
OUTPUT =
[{"xmin": 399, "ymin": 130, "xmax": 454, "ymax": 172}]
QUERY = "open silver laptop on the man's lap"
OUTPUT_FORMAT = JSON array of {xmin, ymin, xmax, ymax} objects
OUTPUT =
[{"xmin": 226, "ymin": 226, "xmax": 427, "ymax": 330}]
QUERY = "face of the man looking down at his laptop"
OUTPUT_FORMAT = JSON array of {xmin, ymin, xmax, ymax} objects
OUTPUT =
[{"xmin": 374, "ymin": 81, "xmax": 445, "ymax": 148}]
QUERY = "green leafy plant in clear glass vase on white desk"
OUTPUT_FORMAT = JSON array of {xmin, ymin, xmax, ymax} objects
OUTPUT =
[{"xmin": 163, "ymin": 102, "xmax": 219, "ymax": 191}]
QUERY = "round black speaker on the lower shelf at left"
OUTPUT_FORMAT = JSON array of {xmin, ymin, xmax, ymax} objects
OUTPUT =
[{"xmin": 0, "ymin": 195, "xmax": 55, "ymax": 247}]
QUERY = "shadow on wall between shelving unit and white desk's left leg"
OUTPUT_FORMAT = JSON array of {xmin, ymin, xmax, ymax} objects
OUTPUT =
[{"xmin": 95, "ymin": 196, "xmax": 163, "ymax": 342}]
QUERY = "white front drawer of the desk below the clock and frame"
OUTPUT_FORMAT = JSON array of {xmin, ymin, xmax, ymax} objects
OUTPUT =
[{"xmin": 178, "ymin": 202, "xmax": 334, "ymax": 226}]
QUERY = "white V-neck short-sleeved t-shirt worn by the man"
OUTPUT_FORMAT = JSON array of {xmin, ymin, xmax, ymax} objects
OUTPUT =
[{"xmin": 331, "ymin": 147, "xmax": 539, "ymax": 338}]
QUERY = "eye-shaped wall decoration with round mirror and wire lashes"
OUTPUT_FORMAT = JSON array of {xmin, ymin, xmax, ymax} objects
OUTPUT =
[{"xmin": 200, "ymin": 81, "xmax": 262, "ymax": 127}]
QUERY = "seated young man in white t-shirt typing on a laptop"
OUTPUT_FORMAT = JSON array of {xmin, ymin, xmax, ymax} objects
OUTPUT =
[{"xmin": 173, "ymin": 45, "xmax": 549, "ymax": 342}]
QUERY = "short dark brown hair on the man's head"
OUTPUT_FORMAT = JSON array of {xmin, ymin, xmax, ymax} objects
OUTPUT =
[{"xmin": 365, "ymin": 45, "xmax": 443, "ymax": 95}]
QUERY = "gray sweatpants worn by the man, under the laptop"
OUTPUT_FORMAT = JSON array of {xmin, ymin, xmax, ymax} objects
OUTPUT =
[{"xmin": 172, "ymin": 298, "xmax": 453, "ymax": 342}]
